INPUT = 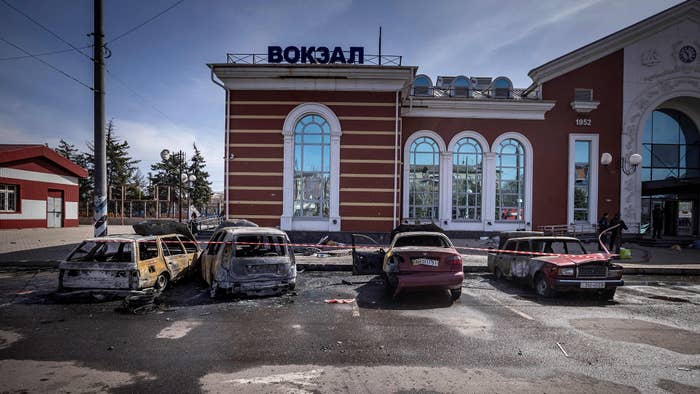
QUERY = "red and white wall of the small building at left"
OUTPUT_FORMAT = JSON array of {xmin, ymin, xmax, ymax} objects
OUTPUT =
[{"xmin": 0, "ymin": 159, "xmax": 79, "ymax": 229}]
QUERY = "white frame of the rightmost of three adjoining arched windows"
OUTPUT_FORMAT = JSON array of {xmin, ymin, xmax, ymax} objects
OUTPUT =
[{"xmin": 490, "ymin": 131, "xmax": 534, "ymax": 231}]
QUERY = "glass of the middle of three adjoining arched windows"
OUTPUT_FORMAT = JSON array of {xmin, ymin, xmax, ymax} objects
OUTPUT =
[{"xmin": 452, "ymin": 137, "xmax": 483, "ymax": 221}]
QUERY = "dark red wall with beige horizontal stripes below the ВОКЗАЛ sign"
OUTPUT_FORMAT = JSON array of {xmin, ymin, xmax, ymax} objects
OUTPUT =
[{"xmin": 227, "ymin": 90, "xmax": 398, "ymax": 232}]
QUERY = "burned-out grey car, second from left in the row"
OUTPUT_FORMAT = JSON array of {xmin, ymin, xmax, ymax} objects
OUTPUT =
[{"xmin": 200, "ymin": 227, "xmax": 297, "ymax": 296}]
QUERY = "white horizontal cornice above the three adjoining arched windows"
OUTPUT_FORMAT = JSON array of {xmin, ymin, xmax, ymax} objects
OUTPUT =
[{"xmin": 401, "ymin": 98, "xmax": 556, "ymax": 120}]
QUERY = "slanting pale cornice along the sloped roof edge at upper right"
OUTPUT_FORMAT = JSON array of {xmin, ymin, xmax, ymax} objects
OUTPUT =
[{"xmin": 528, "ymin": 0, "xmax": 700, "ymax": 84}]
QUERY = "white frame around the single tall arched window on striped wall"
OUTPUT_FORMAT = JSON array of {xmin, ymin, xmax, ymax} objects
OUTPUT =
[{"xmin": 280, "ymin": 103, "xmax": 343, "ymax": 231}]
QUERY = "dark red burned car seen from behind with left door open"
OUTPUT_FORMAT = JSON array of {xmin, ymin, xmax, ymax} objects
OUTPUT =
[{"xmin": 353, "ymin": 225, "xmax": 464, "ymax": 300}]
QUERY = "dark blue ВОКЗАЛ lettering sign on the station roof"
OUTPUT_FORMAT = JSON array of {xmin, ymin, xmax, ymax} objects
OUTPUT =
[{"xmin": 267, "ymin": 46, "xmax": 365, "ymax": 64}]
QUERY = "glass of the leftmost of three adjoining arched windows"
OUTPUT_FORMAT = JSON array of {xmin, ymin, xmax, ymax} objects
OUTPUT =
[{"xmin": 408, "ymin": 137, "xmax": 440, "ymax": 219}]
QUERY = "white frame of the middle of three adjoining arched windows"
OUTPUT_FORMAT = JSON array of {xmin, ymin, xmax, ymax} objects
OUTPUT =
[{"xmin": 441, "ymin": 130, "xmax": 491, "ymax": 231}]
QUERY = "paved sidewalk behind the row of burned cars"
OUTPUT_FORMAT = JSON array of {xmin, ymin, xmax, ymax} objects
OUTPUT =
[{"xmin": 0, "ymin": 225, "xmax": 700, "ymax": 275}]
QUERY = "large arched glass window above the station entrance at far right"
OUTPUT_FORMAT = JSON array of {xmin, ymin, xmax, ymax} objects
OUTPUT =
[{"xmin": 642, "ymin": 109, "xmax": 700, "ymax": 182}]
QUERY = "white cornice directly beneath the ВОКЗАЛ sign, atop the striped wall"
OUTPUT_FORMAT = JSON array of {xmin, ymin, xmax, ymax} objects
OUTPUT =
[{"xmin": 208, "ymin": 63, "xmax": 417, "ymax": 92}]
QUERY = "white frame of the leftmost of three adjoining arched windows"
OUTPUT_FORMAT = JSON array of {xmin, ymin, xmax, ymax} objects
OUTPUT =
[{"xmin": 402, "ymin": 130, "xmax": 452, "ymax": 225}]
